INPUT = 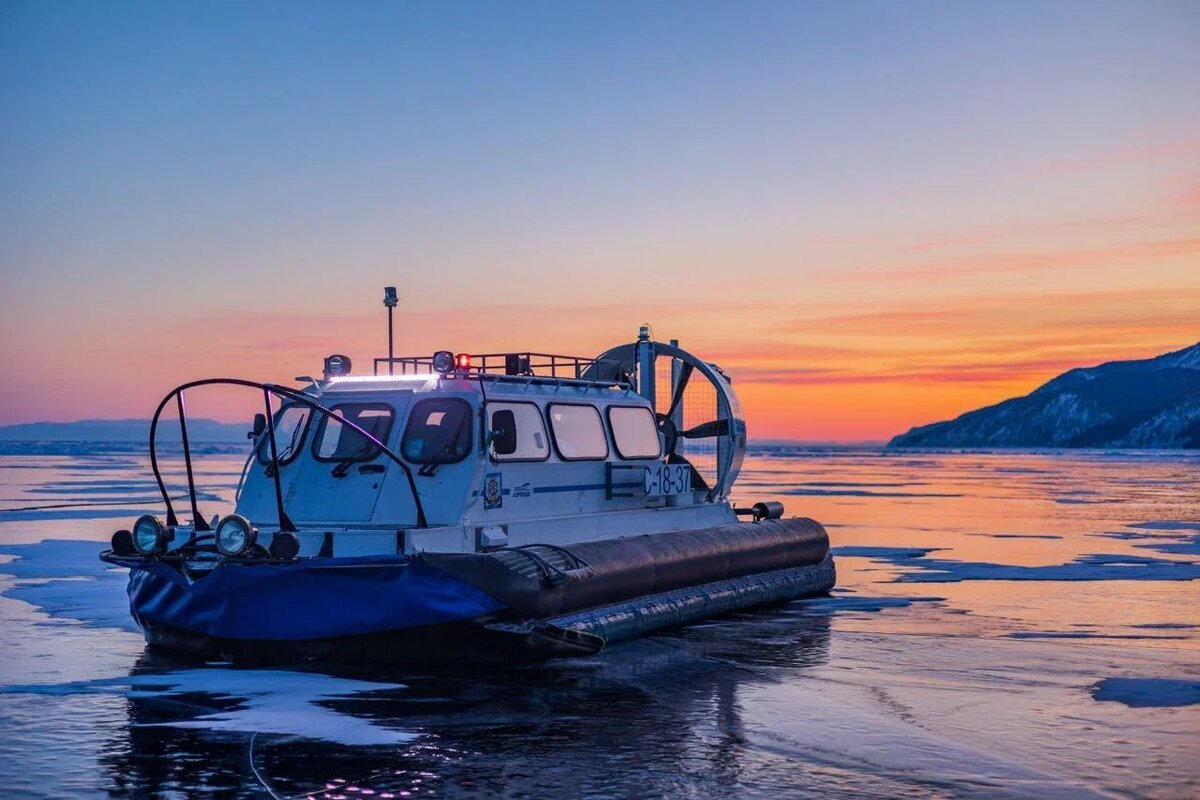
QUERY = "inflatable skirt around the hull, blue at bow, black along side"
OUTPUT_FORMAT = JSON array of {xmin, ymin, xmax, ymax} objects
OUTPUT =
[{"xmin": 130, "ymin": 518, "xmax": 836, "ymax": 663}]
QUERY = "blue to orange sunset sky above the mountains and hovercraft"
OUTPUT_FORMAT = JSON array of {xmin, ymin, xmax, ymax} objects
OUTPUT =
[{"xmin": 0, "ymin": 0, "xmax": 1200, "ymax": 441}]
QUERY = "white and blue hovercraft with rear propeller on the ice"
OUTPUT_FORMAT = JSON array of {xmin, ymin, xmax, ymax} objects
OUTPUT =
[{"xmin": 101, "ymin": 326, "xmax": 835, "ymax": 663}]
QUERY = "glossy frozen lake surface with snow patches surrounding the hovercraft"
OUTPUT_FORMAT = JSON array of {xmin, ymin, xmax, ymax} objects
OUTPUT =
[{"xmin": 0, "ymin": 450, "xmax": 1200, "ymax": 799}]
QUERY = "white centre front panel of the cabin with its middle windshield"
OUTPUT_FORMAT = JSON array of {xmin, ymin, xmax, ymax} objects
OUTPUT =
[{"xmin": 283, "ymin": 397, "xmax": 408, "ymax": 525}]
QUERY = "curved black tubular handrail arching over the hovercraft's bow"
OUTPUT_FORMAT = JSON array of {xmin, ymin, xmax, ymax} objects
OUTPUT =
[{"xmin": 150, "ymin": 378, "xmax": 428, "ymax": 530}]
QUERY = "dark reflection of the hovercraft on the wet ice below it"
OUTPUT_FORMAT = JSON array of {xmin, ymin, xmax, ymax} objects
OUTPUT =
[{"xmin": 100, "ymin": 608, "xmax": 830, "ymax": 798}]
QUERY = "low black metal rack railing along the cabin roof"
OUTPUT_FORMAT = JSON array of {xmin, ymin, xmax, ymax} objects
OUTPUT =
[{"xmin": 374, "ymin": 353, "xmax": 632, "ymax": 386}]
